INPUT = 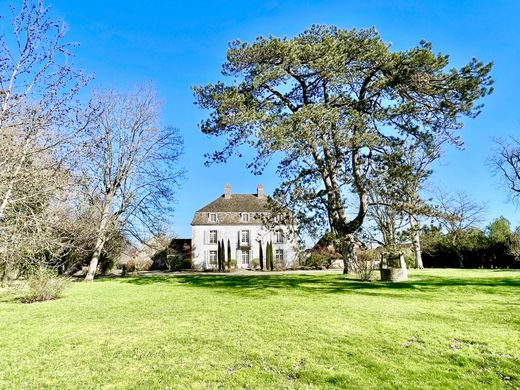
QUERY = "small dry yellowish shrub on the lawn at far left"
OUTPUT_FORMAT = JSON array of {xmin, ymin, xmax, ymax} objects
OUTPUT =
[{"xmin": 23, "ymin": 267, "xmax": 70, "ymax": 303}]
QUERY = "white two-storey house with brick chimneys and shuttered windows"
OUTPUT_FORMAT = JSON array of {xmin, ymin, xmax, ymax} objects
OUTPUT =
[{"xmin": 191, "ymin": 184, "xmax": 298, "ymax": 269}]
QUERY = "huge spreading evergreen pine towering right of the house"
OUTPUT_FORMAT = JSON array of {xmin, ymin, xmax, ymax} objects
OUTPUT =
[{"xmin": 195, "ymin": 26, "xmax": 492, "ymax": 272}]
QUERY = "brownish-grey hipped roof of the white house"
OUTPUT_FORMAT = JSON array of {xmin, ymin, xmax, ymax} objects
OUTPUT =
[{"xmin": 191, "ymin": 194, "xmax": 270, "ymax": 225}]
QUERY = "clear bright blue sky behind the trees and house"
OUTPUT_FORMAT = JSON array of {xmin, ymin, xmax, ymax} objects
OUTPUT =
[{"xmin": 37, "ymin": 0, "xmax": 520, "ymax": 237}]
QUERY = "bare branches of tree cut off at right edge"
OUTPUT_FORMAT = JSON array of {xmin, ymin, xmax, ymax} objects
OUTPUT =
[{"xmin": 491, "ymin": 137, "xmax": 520, "ymax": 199}]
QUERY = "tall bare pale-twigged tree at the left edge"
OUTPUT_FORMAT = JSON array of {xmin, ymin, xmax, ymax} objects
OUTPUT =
[{"xmin": 0, "ymin": 0, "xmax": 89, "ymax": 275}]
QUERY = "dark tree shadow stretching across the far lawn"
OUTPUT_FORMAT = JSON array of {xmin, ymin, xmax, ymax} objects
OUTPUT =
[{"xmin": 106, "ymin": 274, "xmax": 520, "ymax": 298}]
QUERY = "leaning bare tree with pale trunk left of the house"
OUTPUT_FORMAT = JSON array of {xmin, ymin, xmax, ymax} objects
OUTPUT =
[{"xmin": 77, "ymin": 86, "xmax": 183, "ymax": 281}]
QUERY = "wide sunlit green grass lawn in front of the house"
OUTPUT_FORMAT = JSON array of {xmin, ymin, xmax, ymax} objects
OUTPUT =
[{"xmin": 0, "ymin": 270, "xmax": 520, "ymax": 389}]
